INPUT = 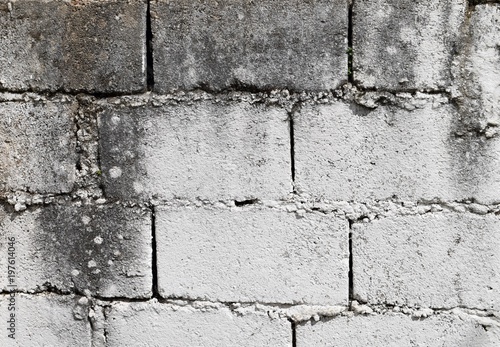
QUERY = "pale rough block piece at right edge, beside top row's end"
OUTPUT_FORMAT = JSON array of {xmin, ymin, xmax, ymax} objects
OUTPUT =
[{"xmin": 453, "ymin": 4, "xmax": 500, "ymax": 137}]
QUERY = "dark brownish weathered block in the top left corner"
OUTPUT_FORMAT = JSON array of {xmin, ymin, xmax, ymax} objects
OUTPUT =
[{"xmin": 0, "ymin": 0, "xmax": 146, "ymax": 93}]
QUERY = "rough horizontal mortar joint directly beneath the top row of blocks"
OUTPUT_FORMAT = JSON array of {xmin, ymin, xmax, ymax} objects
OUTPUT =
[{"xmin": 0, "ymin": 83, "xmax": 451, "ymax": 103}]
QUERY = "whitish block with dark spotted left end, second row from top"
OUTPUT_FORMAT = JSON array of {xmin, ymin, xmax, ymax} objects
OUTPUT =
[{"xmin": 99, "ymin": 101, "xmax": 292, "ymax": 200}]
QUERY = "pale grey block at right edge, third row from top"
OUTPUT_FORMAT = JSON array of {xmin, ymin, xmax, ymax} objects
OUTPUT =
[{"xmin": 353, "ymin": 213, "xmax": 500, "ymax": 310}]
